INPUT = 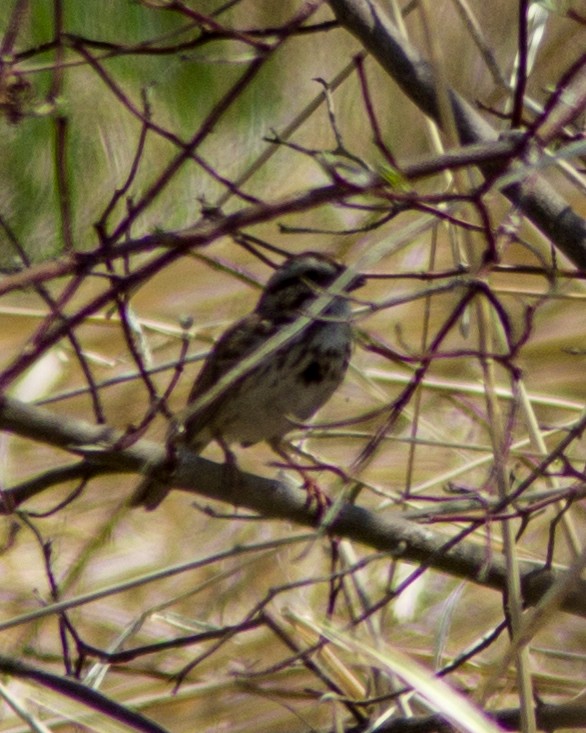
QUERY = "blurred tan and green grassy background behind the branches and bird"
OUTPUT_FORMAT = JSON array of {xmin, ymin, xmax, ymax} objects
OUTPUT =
[{"xmin": 0, "ymin": 0, "xmax": 586, "ymax": 731}]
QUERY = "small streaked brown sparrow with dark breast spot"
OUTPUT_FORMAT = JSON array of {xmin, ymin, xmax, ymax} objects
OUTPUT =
[{"xmin": 131, "ymin": 252, "xmax": 364, "ymax": 509}]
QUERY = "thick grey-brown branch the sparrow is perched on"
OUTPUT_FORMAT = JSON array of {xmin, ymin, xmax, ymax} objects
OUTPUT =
[{"xmin": 0, "ymin": 397, "xmax": 586, "ymax": 616}]
